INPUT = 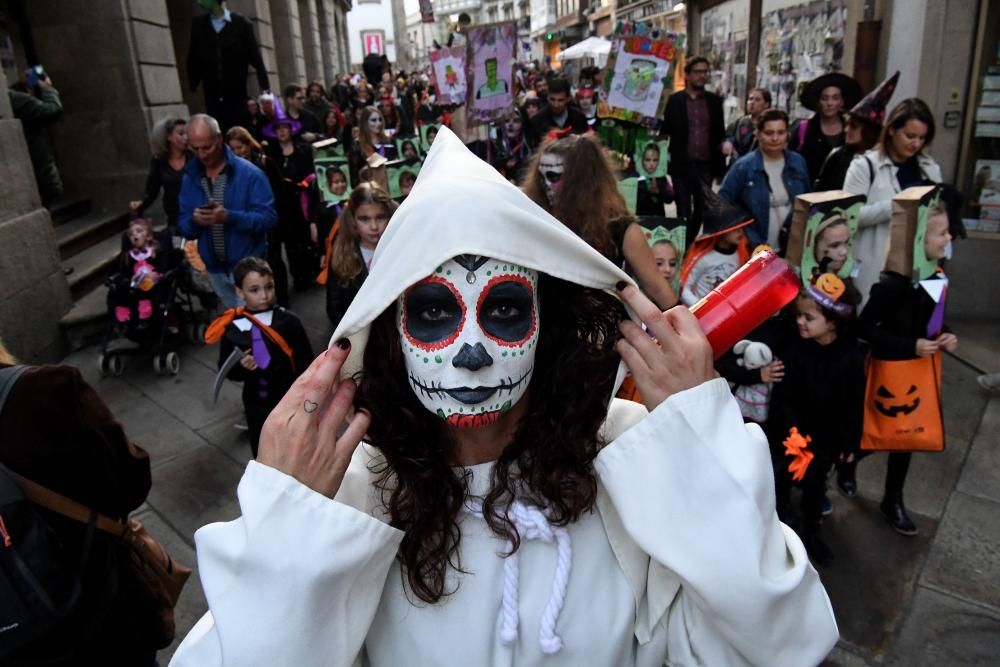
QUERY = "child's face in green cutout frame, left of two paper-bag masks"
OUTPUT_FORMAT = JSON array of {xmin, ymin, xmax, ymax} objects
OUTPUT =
[{"xmin": 801, "ymin": 197, "xmax": 864, "ymax": 286}]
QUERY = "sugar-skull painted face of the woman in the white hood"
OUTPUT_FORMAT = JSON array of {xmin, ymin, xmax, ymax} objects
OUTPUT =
[{"xmin": 396, "ymin": 255, "xmax": 539, "ymax": 428}]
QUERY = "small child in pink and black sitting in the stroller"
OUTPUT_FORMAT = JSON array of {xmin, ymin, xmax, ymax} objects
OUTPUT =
[{"xmin": 108, "ymin": 218, "xmax": 167, "ymax": 324}]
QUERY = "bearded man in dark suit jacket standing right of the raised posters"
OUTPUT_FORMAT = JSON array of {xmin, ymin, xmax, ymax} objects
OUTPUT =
[{"xmin": 663, "ymin": 56, "xmax": 726, "ymax": 245}]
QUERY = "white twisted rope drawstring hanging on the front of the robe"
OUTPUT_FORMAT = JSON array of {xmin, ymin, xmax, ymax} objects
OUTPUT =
[{"xmin": 466, "ymin": 498, "xmax": 573, "ymax": 655}]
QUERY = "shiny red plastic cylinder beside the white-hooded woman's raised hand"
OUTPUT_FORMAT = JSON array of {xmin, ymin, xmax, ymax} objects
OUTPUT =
[{"xmin": 691, "ymin": 251, "xmax": 801, "ymax": 359}]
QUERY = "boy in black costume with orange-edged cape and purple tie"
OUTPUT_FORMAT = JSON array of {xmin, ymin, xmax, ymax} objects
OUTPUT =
[{"xmin": 205, "ymin": 257, "xmax": 313, "ymax": 458}]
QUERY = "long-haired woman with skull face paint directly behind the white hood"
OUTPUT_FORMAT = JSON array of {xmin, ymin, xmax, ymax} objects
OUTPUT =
[{"xmin": 521, "ymin": 134, "xmax": 677, "ymax": 309}]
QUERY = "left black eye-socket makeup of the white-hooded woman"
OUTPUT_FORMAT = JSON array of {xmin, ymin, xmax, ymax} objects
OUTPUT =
[{"xmin": 403, "ymin": 281, "xmax": 465, "ymax": 349}]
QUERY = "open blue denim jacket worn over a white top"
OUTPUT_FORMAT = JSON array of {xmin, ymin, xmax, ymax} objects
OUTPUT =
[{"xmin": 719, "ymin": 149, "xmax": 812, "ymax": 248}]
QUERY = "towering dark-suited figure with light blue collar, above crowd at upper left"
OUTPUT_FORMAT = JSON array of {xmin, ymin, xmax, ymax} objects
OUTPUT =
[{"xmin": 187, "ymin": 0, "xmax": 271, "ymax": 131}]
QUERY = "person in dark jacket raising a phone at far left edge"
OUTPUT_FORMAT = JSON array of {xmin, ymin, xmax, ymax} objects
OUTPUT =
[{"xmin": 7, "ymin": 75, "xmax": 63, "ymax": 206}]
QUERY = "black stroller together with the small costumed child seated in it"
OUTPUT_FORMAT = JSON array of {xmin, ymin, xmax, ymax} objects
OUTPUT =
[{"xmin": 97, "ymin": 218, "xmax": 204, "ymax": 375}]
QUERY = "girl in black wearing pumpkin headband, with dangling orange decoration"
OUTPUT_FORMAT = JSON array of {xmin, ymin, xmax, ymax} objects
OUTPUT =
[{"xmin": 766, "ymin": 262, "xmax": 865, "ymax": 565}]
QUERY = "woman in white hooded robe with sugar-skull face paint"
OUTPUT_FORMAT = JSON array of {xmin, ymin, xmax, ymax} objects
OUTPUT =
[{"xmin": 171, "ymin": 128, "xmax": 838, "ymax": 667}]
